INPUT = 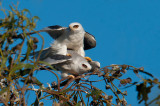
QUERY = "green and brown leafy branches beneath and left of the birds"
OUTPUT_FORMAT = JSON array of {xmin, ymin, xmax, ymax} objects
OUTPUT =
[{"xmin": 0, "ymin": 5, "xmax": 160, "ymax": 106}]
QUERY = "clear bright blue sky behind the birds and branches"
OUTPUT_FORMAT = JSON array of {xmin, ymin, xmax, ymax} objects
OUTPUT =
[{"xmin": 0, "ymin": 0, "xmax": 160, "ymax": 106}]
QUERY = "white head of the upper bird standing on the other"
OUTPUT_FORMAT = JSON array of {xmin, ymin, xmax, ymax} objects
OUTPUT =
[{"xmin": 69, "ymin": 22, "xmax": 84, "ymax": 32}]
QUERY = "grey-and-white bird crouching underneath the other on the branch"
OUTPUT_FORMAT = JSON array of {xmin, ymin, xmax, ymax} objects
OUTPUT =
[{"xmin": 32, "ymin": 46, "xmax": 92, "ymax": 77}]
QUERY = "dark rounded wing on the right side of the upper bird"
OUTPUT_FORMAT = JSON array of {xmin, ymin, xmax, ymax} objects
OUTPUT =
[{"xmin": 84, "ymin": 32, "xmax": 96, "ymax": 50}]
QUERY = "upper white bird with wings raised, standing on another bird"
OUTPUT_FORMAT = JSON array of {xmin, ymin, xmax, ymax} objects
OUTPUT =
[{"xmin": 38, "ymin": 22, "xmax": 96, "ymax": 57}]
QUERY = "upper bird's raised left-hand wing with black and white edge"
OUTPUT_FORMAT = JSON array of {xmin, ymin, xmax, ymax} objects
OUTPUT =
[{"xmin": 39, "ymin": 25, "xmax": 67, "ymax": 39}]
